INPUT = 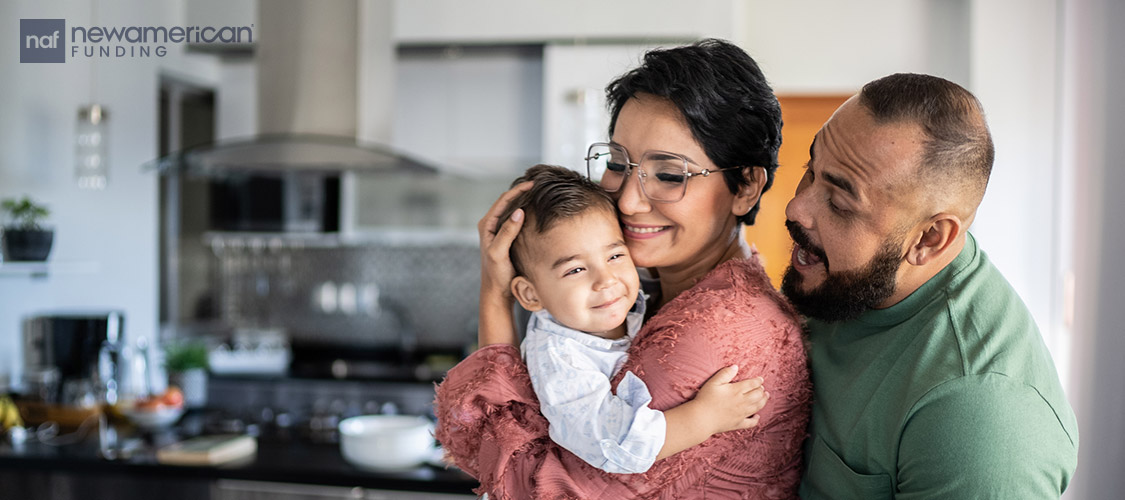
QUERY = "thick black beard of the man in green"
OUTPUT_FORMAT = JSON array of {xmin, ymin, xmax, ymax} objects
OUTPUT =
[{"xmin": 781, "ymin": 221, "xmax": 902, "ymax": 321}]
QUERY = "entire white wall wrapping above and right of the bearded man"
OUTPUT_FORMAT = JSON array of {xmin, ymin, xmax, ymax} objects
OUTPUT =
[{"xmin": 736, "ymin": 0, "xmax": 1069, "ymax": 367}]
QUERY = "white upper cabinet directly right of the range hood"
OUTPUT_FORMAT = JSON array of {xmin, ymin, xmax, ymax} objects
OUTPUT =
[{"xmin": 394, "ymin": 45, "xmax": 543, "ymax": 176}]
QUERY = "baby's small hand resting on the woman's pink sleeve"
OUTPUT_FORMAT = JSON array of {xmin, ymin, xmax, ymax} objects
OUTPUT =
[{"xmin": 692, "ymin": 365, "xmax": 770, "ymax": 435}]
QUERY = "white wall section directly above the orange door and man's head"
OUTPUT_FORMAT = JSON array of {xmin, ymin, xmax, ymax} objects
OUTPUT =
[{"xmin": 734, "ymin": 0, "xmax": 965, "ymax": 95}]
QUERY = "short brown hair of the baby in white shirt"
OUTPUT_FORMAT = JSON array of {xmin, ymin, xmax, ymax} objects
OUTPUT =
[{"xmin": 500, "ymin": 164, "xmax": 617, "ymax": 276}]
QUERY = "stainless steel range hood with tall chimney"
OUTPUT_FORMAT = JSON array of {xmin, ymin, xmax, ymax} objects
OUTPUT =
[{"xmin": 149, "ymin": 0, "xmax": 429, "ymax": 176}]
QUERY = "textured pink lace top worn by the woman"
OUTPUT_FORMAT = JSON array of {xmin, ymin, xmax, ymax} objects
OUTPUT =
[{"xmin": 434, "ymin": 255, "xmax": 811, "ymax": 500}]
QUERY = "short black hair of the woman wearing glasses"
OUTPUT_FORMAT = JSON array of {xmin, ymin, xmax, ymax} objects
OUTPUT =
[{"xmin": 605, "ymin": 38, "xmax": 782, "ymax": 224}]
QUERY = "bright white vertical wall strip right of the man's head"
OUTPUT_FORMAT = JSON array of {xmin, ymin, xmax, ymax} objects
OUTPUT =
[{"xmin": 969, "ymin": 0, "xmax": 1069, "ymax": 371}]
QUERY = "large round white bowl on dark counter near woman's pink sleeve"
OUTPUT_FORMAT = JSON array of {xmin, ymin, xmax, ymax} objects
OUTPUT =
[{"xmin": 340, "ymin": 414, "xmax": 437, "ymax": 471}]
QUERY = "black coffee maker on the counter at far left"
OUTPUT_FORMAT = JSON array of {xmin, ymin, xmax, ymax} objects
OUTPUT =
[{"xmin": 17, "ymin": 311, "xmax": 125, "ymax": 428}]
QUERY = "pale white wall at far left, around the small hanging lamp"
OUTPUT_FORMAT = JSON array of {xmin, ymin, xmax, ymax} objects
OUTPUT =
[{"xmin": 0, "ymin": 0, "xmax": 226, "ymax": 382}]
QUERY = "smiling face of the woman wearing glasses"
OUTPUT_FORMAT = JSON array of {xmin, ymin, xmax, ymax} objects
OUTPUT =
[{"xmin": 612, "ymin": 93, "xmax": 757, "ymax": 275}]
